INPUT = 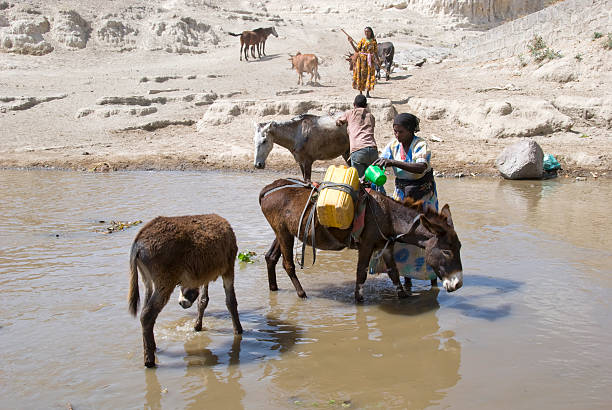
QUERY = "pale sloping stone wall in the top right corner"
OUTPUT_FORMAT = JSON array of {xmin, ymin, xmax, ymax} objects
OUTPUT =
[{"xmin": 458, "ymin": 0, "xmax": 612, "ymax": 61}]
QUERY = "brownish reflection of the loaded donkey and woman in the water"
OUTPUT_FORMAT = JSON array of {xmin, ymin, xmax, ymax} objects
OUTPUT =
[{"xmin": 267, "ymin": 285, "xmax": 461, "ymax": 408}]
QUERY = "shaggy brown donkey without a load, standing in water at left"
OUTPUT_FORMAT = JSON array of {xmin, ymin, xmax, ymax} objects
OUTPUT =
[{"xmin": 128, "ymin": 214, "xmax": 242, "ymax": 367}]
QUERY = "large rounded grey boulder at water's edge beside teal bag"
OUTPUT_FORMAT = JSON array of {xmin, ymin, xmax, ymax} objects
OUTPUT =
[{"xmin": 495, "ymin": 140, "xmax": 544, "ymax": 179}]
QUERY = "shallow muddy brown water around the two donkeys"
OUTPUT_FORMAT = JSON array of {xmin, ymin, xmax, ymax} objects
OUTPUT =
[{"xmin": 0, "ymin": 171, "xmax": 612, "ymax": 409}]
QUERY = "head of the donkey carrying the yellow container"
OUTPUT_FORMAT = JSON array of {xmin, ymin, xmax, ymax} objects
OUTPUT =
[{"xmin": 395, "ymin": 204, "xmax": 463, "ymax": 292}]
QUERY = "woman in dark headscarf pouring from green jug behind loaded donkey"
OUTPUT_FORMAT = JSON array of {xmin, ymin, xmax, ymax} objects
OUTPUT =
[{"xmin": 374, "ymin": 113, "xmax": 438, "ymax": 286}]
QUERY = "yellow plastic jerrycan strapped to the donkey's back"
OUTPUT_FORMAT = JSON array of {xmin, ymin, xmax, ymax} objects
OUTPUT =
[{"xmin": 317, "ymin": 165, "xmax": 359, "ymax": 229}]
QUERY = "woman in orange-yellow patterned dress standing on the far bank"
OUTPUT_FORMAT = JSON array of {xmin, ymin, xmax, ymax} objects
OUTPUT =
[{"xmin": 349, "ymin": 27, "xmax": 380, "ymax": 97}]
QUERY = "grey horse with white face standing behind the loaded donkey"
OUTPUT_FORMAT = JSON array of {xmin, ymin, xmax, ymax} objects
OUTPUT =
[{"xmin": 253, "ymin": 114, "xmax": 350, "ymax": 181}]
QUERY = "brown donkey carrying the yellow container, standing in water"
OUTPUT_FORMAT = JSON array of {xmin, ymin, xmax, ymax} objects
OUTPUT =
[{"xmin": 259, "ymin": 179, "xmax": 463, "ymax": 302}]
